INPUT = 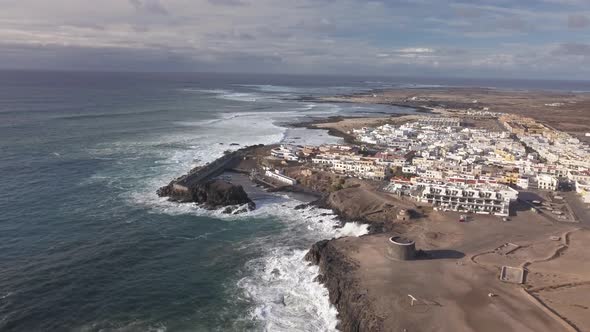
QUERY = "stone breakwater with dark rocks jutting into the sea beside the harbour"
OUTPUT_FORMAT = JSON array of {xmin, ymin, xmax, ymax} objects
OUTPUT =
[{"xmin": 157, "ymin": 145, "xmax": 262, "ymax": 214}]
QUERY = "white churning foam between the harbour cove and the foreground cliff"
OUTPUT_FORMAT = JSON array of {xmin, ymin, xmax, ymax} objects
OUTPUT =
[{"xmin": 238, "ymin": 203, "xmax": 368, "ymax": 331}]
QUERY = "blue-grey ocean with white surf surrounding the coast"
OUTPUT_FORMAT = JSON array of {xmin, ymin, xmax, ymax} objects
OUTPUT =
[{"xmin": 0, "ymin": 71, "xmax": 590, "ymax": 331}]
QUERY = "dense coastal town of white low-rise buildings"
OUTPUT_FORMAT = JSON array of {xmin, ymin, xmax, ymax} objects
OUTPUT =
[{"xmin": 272, "ymin": 110, "xmax": 590, "ymax": 216}]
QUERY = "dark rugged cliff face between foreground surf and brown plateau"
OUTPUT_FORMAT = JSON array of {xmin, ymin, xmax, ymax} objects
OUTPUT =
[{"xmin": 305, "ymin": 240, "xmax": 383, "ymax": 332}]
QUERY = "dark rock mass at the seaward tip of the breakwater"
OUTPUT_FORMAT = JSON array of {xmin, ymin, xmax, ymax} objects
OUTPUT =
[{"xmin": 157, "ymin": 180, "xmax": 256, "ymax": 213}]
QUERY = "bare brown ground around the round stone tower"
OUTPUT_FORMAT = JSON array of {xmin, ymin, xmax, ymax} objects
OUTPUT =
[{"xmin": 312, "ymin": 204, "xmax": 590, "ymax": 331}]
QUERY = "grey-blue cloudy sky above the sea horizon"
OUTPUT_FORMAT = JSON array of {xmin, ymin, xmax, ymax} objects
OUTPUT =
[{"xmin": 0, "ymin": 0, "xmax": 590, "ymax": 79}]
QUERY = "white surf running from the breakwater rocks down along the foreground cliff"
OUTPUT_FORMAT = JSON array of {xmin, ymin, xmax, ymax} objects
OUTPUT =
[{"xmin": 128, "ymin": 188, "xmax": 368, "ymax": 331}]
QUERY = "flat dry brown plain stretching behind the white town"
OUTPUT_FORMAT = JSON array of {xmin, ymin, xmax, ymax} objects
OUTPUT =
[{"xmin": 322, "ymin": 88, "xmax": 590, "ymax": 141}]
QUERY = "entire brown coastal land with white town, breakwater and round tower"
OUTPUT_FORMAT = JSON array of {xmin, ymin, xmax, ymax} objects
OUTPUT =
[{"xmin": 158, "ymin": 88, "xmax": 590, "ymax": 331}]
